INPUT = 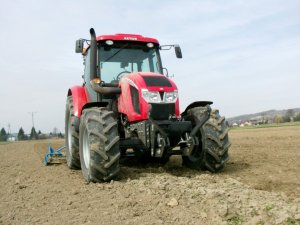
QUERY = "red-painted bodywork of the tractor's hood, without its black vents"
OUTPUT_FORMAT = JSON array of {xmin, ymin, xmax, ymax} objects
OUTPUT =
[{"xmin": 118, "ymin": 72, "xmax": 179, "ymax": 122}]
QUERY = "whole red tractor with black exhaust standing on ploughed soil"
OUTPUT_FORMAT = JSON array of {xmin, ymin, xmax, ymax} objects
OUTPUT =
[{"xmin": 65, "ymin": 28, "xmax": 230, "ymax": 182}]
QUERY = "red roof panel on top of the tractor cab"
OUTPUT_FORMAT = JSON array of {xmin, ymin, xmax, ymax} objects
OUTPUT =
[{"xmin": 96, "ymin": 34, "xmax": 159, "ymax": 44}]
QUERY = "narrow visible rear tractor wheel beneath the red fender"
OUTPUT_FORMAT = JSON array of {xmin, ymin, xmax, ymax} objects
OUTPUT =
[{"xmin": 65, "ymin": 96, "xmax": 80, "ymax": 169}]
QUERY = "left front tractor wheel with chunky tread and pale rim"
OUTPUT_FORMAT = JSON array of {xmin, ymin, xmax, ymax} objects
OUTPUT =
[{"xmin": 79, "ymin": 107, "xmax": 120, "ymax": 182}]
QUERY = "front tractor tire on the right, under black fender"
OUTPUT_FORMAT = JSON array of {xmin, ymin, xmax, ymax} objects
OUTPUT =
[{"xmin": 182, "ymin": 107, "xmax": 230, "ymax": 172}]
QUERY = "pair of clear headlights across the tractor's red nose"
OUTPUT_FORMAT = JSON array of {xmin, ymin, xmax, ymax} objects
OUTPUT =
[{"xmin": 142, "ymin": 89, "xmax": 178, "ymax": 103}]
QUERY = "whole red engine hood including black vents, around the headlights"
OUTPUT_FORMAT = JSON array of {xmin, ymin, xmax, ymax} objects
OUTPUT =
[{"xmin": 118, "ymin": 72, "xmax": 180, "ymax": 121}]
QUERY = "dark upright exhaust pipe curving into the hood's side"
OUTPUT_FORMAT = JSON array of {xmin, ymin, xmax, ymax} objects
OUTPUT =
[{"xmin": 90, "ymin": 28, "xmax": 121, "ymax": 95}]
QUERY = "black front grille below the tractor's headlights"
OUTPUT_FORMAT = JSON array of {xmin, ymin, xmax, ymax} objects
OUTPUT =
[{"xmin": 150, "ymin": 103, "xmax": 175, "ymax": 120}]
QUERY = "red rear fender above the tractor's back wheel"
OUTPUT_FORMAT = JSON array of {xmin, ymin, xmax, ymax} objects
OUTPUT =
[{"xmin": 68, "ymin": 86, "xmax": 89, "ymax": 118}]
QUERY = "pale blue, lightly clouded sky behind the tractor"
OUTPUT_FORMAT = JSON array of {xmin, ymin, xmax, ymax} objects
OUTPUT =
[{"xmin": 0, "ymin": 0, "xmax": 300, "ymax": 133}]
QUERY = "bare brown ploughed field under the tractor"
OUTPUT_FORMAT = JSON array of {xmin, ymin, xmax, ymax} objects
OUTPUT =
[{"xmin": 0, "ymin": 126, "xmax": 300, "ymax": 225}]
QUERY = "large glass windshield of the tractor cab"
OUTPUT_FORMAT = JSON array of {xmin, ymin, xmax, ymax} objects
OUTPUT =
[{"xmin": 99, "ymin": 42, "xmax": 162, "ymax": 83}]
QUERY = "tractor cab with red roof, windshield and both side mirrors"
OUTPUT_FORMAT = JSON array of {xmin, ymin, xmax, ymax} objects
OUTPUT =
[{"xmin": 75, "ymin": 34, "xmax": 182, "ymax": 83}]
